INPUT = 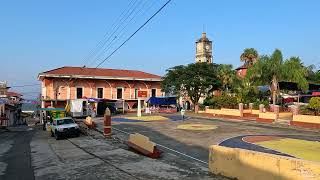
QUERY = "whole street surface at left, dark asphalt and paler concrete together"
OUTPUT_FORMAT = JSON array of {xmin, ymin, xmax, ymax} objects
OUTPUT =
[{"xmin": 0, "ymin": 125, "xmax": 225, "ymax": 180}]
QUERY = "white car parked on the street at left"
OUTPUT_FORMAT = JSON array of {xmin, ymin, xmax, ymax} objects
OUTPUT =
[{"xmin": 50, "ymin": 117, "xmax": 80, "ymax": 140}]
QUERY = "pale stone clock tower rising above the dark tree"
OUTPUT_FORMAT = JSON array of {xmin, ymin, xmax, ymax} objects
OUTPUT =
[{"xmin": 196, "ymin": 32, "xmax": 212, "ymax": 63}]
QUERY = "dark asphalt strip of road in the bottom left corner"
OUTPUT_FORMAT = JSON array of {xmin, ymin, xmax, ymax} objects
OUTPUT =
[{"xmin": 0, "ymin": 127, "xmax": 34, "ymax": 180}]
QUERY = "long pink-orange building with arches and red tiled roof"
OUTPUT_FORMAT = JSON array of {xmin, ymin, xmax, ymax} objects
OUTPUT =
[{"xmin": 38, "ymin": 67, "xmax": 163, "ymax": 109}]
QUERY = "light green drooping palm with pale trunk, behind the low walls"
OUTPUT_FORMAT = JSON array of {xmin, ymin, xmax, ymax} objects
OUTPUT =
[{"xmin": 247, "ymin": 49, "xmax": 308, "ymax": 105}]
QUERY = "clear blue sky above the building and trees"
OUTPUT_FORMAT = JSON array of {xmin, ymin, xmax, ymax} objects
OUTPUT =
[{"xmin": 0, "ymin": 0, "xmax": 320, "ymax": 98}]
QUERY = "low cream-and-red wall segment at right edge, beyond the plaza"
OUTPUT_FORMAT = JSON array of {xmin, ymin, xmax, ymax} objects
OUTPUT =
[{"xmin": 290, "ymin": 115, "xmax": 320, "ymax": 129}]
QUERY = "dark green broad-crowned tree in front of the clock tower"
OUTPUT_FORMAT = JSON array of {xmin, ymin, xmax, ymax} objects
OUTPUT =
[{"xmin": 161, "ymin": 63, "xmax": 221, "ymax": 113}]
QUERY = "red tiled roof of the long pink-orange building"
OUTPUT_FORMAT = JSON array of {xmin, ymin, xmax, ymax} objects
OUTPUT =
[{"xmin": 39, "ymin": 66, "xmax": 161, "ymax": 80}]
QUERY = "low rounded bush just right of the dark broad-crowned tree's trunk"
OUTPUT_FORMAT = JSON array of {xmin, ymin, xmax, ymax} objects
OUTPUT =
[{"xmin": 203, "ymin": 95, "xmax": 238, "ymax": 109}]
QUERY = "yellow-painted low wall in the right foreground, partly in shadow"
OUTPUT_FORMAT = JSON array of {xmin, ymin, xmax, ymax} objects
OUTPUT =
[{"xmin": 209, "ymin": 145, "xmax": 320, "ymax": 180}]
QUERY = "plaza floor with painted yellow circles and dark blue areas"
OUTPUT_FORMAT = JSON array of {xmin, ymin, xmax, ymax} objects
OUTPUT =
[{"xmin": 93, "ymin": 114, "xmax": 320, "ymax": 162}]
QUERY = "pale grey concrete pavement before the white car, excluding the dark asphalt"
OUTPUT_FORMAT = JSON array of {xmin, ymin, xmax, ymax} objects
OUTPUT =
[{"xmin": 31, "ymin": 125, "xmax": 224, "ymax": 179}]
